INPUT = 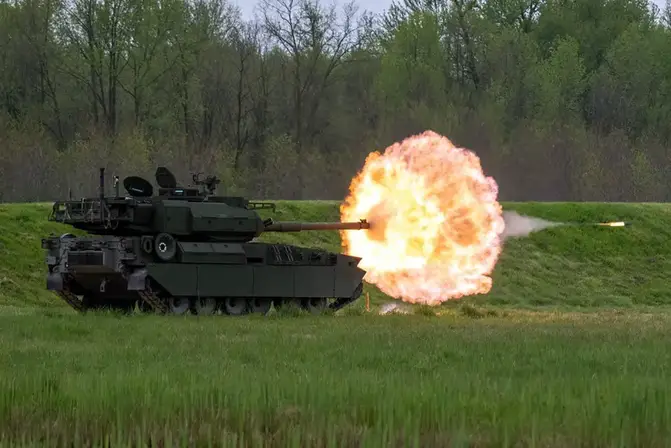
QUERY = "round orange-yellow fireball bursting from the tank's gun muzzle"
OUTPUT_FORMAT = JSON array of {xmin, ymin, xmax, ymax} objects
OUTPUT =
[{"xmin": 340, "ymin": 131, "xmax": 504, "ymax": 305}]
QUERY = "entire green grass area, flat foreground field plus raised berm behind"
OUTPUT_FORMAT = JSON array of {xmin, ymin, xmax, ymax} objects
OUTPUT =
[{"xmin": 0, "ymin": 202, "xmax": 671, "ymax": 447}]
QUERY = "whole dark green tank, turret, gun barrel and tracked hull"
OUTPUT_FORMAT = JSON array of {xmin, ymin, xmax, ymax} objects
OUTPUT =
[{"xmin": 42, "ymin": 167, "xmax": 369, "ymax": 315}]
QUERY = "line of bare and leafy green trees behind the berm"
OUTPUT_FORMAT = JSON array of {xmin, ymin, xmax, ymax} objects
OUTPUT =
[{"xmin": 0, "ymin": 0, "xmax": 671, "ymax": 201}]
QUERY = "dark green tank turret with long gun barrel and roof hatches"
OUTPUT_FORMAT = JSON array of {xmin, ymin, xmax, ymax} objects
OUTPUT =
[{"xmin": 49, "ymin": 167, "xmax": 368, "ymax": 242}]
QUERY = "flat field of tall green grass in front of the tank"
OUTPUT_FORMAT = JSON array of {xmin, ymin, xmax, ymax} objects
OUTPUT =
[{"xmin": 0, "ymin": 312, "xmax": 671, "ymax": 447}]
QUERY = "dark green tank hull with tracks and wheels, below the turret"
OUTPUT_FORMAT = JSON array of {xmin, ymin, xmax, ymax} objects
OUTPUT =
[{"xmin": 43, "ymin": 235, "xmax": 365, "ymax": 314}]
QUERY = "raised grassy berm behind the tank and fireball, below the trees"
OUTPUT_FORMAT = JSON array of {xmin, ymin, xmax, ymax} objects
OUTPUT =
[{"xmin": 0, "ymin": 201, "xmax": 671, "ymax": 309}]
